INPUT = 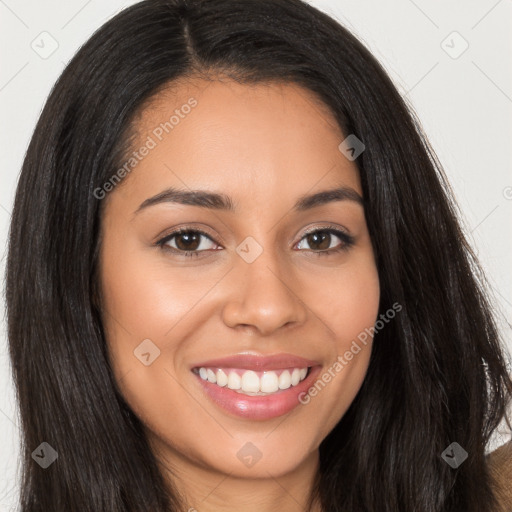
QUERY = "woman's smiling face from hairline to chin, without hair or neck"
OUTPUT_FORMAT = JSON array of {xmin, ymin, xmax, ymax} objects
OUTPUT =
[{"xmin": 101, "ymin": 80, "xmax": 379, "ymax": 477}]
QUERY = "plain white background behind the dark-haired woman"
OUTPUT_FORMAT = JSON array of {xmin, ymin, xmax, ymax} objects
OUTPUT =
[{"xmin": 0, "ymin": 0, "xmax": 512, "ymax": 511}]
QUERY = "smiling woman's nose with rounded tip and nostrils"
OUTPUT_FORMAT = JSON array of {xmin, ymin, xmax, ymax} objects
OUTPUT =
[{"xmin": 222, "ymin": 243, "xmax": 308, "ymax": 336}]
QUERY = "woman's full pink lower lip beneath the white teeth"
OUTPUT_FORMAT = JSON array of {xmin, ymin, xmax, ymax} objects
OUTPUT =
[{"xmin": 194, "ymin": 366, "xmax": 321, "ymax": 420}]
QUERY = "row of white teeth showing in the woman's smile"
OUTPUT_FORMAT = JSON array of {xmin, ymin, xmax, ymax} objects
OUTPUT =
[{"xmin": 199, "ymin": 368, "xmax": 308, "ymax": 395}]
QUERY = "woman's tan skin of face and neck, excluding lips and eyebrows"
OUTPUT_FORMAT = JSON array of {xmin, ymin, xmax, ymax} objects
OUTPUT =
[{"xmin": 100, "ymin": 79, "xmax": 380, "ymax": 512}]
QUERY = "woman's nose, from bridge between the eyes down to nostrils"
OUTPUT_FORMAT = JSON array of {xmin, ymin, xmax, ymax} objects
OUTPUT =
[{"xmin": 224, "ymin": 236, "xmax": 305, "ymax": 333}]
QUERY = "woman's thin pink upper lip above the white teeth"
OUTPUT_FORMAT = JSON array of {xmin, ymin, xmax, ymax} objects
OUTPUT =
[{"xmin": 192, "ymin": 353, "xmax": 320, "ymax": 371}]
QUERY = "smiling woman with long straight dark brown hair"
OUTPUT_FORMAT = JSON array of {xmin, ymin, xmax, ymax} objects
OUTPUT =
[{"xmin": 7, "ymin": 0, "xmax": 512, "ymax": 512}]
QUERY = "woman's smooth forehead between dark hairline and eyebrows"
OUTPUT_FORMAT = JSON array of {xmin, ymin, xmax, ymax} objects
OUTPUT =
[{"xmin": 110, "ymin": 79, "xmax": 361, "ymax": 212}]
